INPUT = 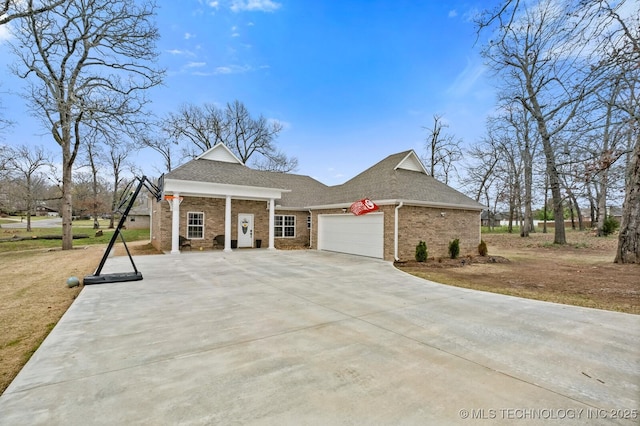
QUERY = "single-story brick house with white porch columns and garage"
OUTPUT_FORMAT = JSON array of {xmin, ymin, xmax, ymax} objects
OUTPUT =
[{"xmin": 151, "ymin": 144, "xmax": 486, "ymax": 261}]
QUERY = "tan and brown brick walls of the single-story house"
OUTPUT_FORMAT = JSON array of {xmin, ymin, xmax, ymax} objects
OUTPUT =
[{"xmin": 152, "ymin": 197, "xmax": 480, "ymax": 261}]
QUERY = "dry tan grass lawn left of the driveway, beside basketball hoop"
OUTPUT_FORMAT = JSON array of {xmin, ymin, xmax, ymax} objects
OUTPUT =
[{"xmin": 0, "ymin": 242, "xmax": 156, "ymax": 393}]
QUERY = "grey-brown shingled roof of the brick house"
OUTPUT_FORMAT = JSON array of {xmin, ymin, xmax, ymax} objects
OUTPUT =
[{"xmin": 165, "ymin": 146, "xmax": 484, "ymax": 210}]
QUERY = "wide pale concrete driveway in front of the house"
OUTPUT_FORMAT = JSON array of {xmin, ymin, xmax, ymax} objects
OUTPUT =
[{"xmin": 0, "ymin": 250, "xmax": 640, "ymax": 426}]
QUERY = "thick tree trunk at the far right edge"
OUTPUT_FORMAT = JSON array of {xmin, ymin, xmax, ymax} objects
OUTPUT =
[{"xmin": 615, "ymin": 134, "xmax": 640, "ymax": 264}]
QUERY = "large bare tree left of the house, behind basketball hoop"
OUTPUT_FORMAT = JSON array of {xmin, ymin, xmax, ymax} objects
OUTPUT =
[{"xmin": 5, "ymin": 0, "xmax": 163, "ymax": 249}]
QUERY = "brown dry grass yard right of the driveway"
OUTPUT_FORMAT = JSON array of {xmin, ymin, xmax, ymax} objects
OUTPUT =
[{"xmin": 397, "ymin": 230, "xmax": 640, "ymax": 314}]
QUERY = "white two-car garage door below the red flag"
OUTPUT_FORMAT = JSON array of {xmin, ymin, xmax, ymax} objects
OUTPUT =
[{"xmin": 318, "ymin": 213, "xmax": 384, "ymax": 259}]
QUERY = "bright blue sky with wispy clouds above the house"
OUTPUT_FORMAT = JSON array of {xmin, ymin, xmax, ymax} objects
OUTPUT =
[{"xmin": 0, "ymin": 0, "xmax": 495, "ymax": 185}]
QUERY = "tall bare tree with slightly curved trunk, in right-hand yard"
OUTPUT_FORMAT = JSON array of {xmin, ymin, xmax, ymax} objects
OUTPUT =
[{"xmin": 483, "ymin": 0, "xmax": 601, "ymax": 244}]
